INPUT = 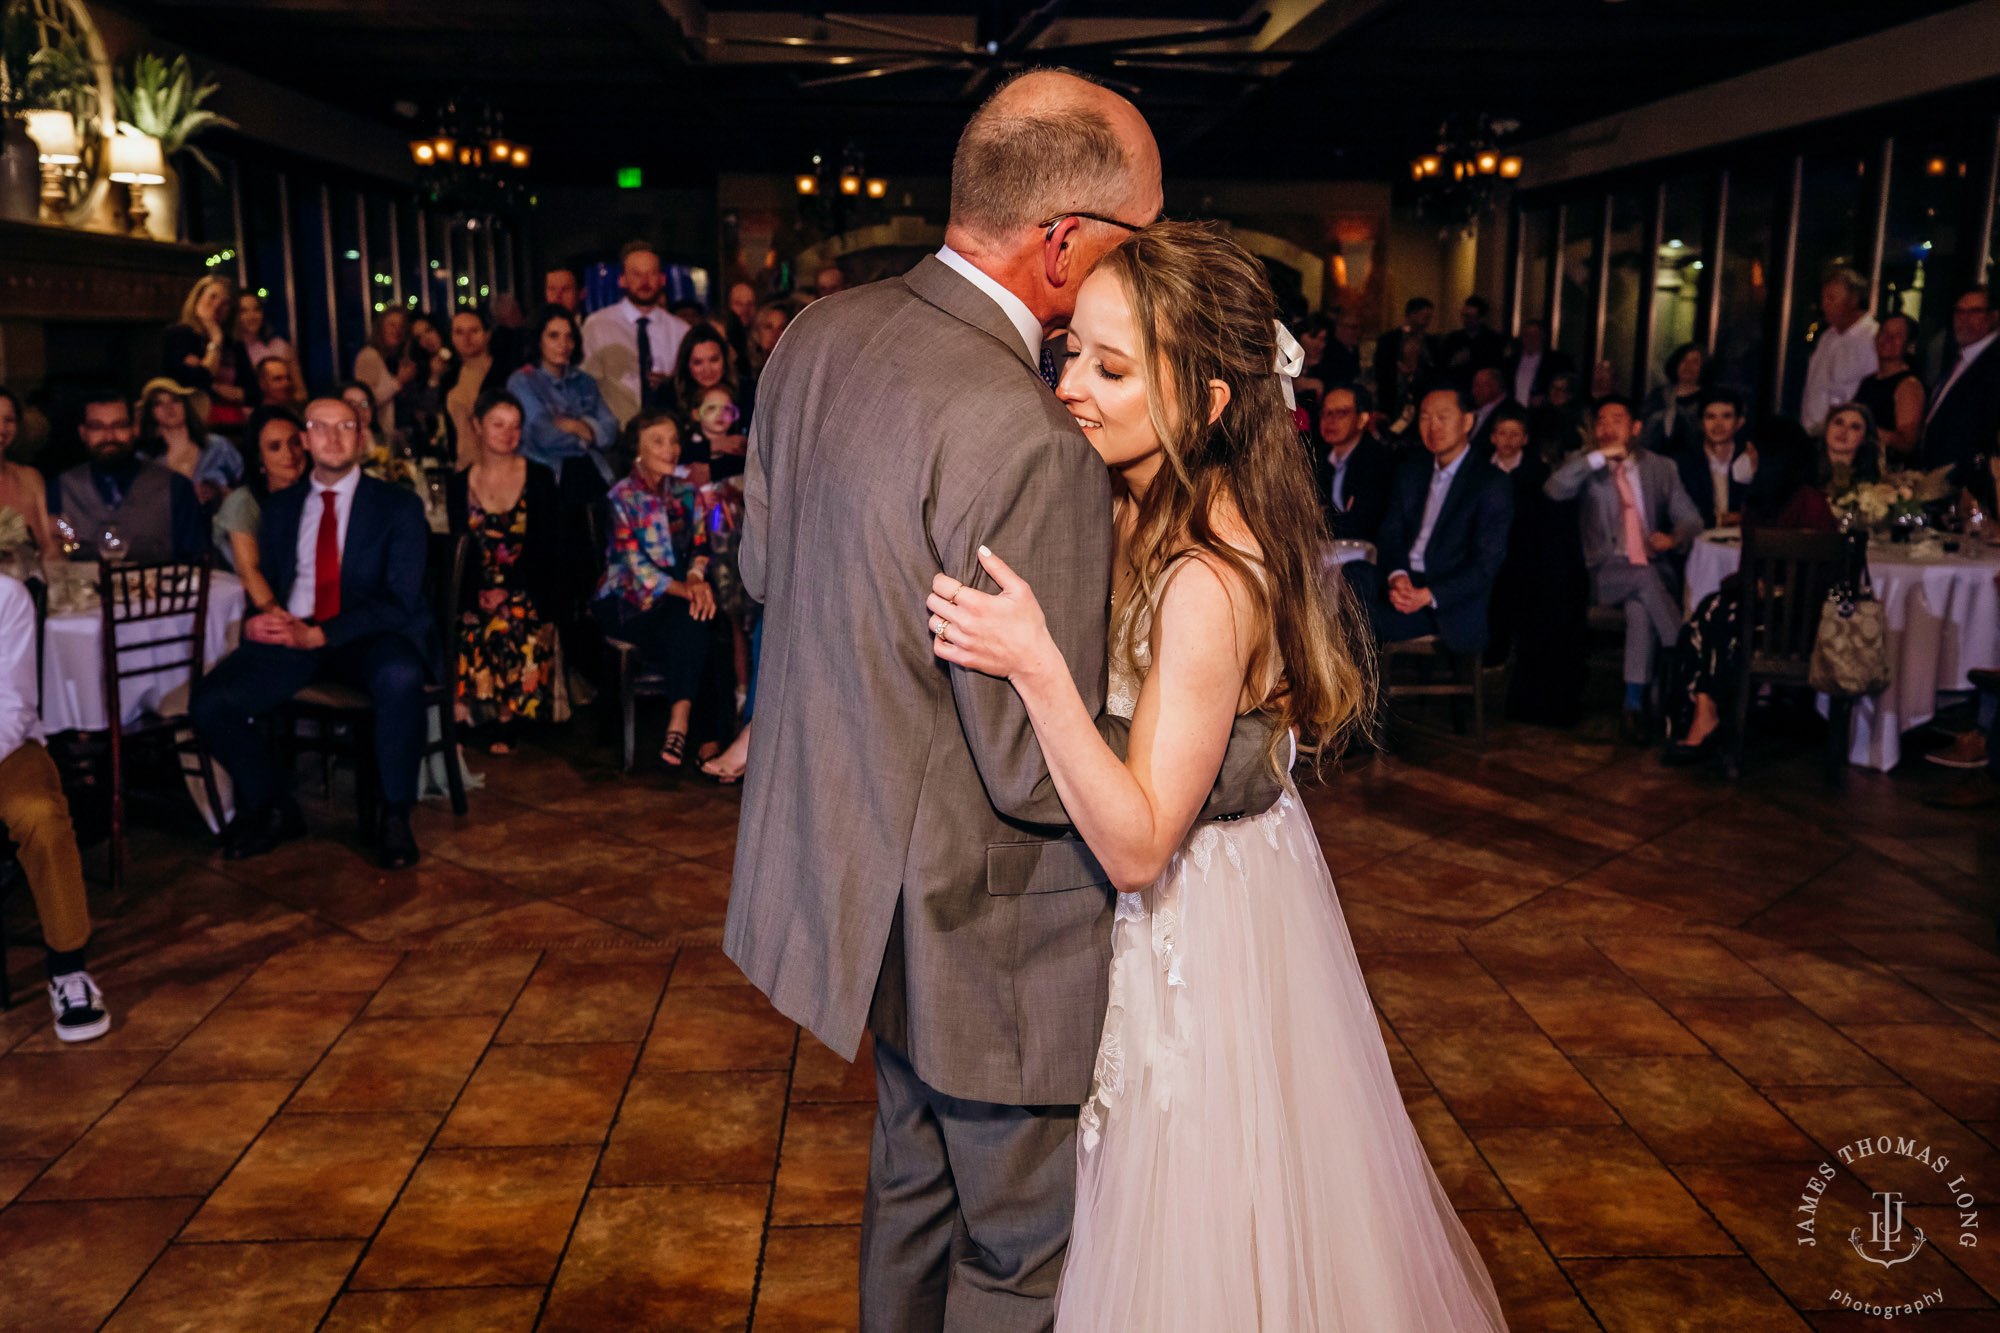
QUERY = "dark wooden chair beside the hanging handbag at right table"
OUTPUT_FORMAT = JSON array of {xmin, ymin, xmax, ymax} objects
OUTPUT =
[{"xmin": 1716, "ymin": 526, "xmax": 1854, "ymax": 783}]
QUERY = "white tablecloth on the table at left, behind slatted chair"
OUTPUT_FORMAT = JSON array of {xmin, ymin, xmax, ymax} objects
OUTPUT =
[{"xmin": 42, "ymin": 570, "xmax": 244, "ymax": 733}]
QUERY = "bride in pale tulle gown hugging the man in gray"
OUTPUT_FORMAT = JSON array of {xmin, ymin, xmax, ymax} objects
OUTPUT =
[{"xmin": 928, "ymin": 222, "xmax": 1506, "ymax": 1333}]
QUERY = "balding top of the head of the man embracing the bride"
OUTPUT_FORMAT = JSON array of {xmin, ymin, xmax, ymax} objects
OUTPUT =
[{"xmin": 950, "ymin": 70, "xmax": 1160, "ymax": 242}]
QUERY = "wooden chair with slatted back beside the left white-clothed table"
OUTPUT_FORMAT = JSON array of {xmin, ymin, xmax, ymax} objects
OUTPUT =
[{"xmin": 98, "ymin": 560, "xmax": 222, "ymax": 895}]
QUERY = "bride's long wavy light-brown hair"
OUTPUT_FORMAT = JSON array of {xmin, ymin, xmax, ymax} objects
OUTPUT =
[{"xmin": 1100, "ymin": 222, "xmax": 1374, "ymax": 755}]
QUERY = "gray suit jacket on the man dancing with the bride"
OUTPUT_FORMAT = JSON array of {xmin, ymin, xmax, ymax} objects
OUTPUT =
[{"xmin": 724, "ymin": 258, "xmax": 1278, "ymax": 1105}]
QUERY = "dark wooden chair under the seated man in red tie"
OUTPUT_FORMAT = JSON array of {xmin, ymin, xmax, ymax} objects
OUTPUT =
[{"xmin": 278, "ymin": 532, "xmax": 472, "ymax": 841}]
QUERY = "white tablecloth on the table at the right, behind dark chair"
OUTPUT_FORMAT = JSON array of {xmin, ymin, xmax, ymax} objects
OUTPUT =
[{"xmin": 1688, "ymin": 532, "xmax": 2000, "ymax": 773}]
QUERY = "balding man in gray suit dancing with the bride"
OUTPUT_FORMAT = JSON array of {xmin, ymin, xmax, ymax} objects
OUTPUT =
[{"xmin": 724, "ymin": 70, "xmax": 1278, "ymax": 1333}]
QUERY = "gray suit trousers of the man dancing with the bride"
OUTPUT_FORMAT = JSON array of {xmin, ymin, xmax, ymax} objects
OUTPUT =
[{"xmin": 862, "ymin": 1037, "xmax": 1078, "ymax": 1333}]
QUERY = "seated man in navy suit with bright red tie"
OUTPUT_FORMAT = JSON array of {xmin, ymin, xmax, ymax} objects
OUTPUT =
[{"xmin": 188, "ymin": 398, "xmax": 440, "ymax": 871}]
